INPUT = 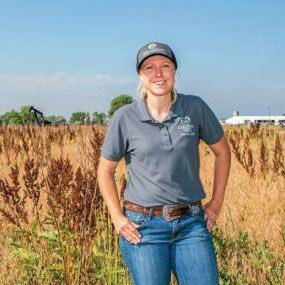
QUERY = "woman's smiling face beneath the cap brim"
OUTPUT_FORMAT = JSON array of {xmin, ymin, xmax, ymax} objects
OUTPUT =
[{"xmin": 139, "ymin": 55, "xmax": 175, "ymax": 96}]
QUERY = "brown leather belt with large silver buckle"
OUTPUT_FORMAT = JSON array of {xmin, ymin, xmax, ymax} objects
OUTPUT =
[{"xmin": 123, "ymin": 200, "xmax": 202, "ymax": 221}]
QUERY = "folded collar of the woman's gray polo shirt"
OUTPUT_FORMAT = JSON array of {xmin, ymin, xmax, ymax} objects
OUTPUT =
[{"xmin": 138, "ymin": 94, "xmax": 183, "ymax": 122}]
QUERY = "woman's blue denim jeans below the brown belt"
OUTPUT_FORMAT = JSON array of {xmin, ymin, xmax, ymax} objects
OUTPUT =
[{"xmin": 119, "ymin": 205, "xmax": 219, "ymax": 285}]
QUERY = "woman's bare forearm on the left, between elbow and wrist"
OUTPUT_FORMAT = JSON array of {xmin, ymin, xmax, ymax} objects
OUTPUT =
[{"xmin": 98, "ymin": 169, "xmax": 122, "ymax": 221}]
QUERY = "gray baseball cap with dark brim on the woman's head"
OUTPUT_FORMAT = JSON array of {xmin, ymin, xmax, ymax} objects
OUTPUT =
[{"xmin": 137, "ymin": 42, "xmax": 177, "ymax": 72}]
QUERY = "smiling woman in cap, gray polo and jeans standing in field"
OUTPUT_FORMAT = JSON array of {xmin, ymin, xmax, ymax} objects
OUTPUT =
[{"xmin": 98, "ymin": 42, "xmax": 230, "ymax": 285}]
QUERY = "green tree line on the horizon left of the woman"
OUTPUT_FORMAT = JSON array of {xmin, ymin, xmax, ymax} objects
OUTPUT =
[{"xmin": 0, "ymin": 94, "xmax": 135, "ymax": 125}]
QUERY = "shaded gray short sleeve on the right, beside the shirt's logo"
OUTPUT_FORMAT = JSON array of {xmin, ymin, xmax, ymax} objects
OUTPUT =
[{"xmin": 199, "ymin": 99, "xmax": 224, "ymax": 144}]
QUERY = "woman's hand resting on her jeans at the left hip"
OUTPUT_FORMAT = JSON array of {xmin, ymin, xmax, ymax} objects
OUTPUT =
[{"xmin": 113, "ymin": 215, "xmax": 141, "ymax": 244}]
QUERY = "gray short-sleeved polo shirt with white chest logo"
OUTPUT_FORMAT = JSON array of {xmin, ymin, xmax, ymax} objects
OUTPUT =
[{"xmin": 101, "ymin": 94, "xmax": 223, "ymax": 207}]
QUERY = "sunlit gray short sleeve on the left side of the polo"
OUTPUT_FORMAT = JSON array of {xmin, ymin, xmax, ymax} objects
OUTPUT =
[{"xmin": 101, "ymin": 110, "xmax": 127, "ymax": 161}]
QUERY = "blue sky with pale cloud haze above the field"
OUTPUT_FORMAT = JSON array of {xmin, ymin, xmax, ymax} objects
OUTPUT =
[{"xmin": 0, "ymin": 0, "xmax": 285, "ymax": 119}]
